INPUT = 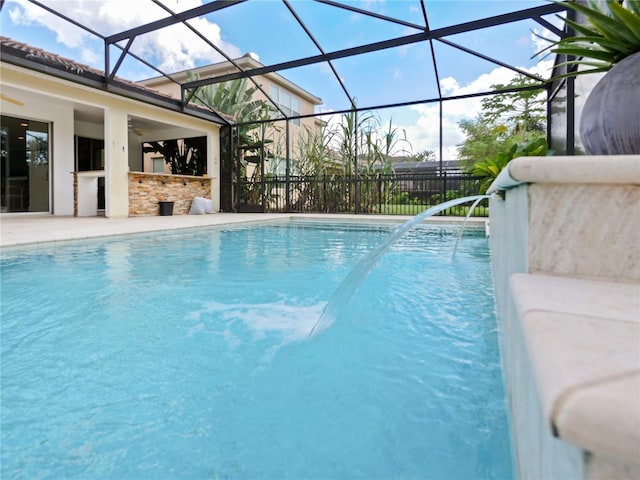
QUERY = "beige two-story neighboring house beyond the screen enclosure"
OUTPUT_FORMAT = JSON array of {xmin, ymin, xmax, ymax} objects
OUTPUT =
[{"xmin": 138, "ymin": 53, "xmax": 324, "ymax": 174}]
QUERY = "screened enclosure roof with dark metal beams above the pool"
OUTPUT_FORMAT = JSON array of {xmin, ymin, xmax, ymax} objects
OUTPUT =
[{"xmin": 0, "ymin": 0, "xmax": 558, "ymax": 124}]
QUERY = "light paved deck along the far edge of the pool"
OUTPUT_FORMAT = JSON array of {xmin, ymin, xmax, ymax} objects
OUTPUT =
[{"xmin": 0, "ymin": 213, "xmax": 487, "ymax": 248}]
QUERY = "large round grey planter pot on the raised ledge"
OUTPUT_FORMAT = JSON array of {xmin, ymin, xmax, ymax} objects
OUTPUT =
[{"xmin": 580, "ymin": 52, "xmax": 640, "ymax": 155}]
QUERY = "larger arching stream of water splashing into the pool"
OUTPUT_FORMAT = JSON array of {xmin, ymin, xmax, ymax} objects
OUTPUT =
[{"xmin": 309, "ymin": 195, "xmax": 490, "ymax": 336}]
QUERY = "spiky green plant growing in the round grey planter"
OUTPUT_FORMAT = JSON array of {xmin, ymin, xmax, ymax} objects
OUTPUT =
[{"xmin": 536, "ymin": 0, "xmax": 640, "ymax": 78}]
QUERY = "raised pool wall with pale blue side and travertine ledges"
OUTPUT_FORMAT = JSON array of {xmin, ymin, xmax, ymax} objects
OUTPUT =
[{"xmin": 489, "ymin": 155, "xmax": 640, "ymax": 480}]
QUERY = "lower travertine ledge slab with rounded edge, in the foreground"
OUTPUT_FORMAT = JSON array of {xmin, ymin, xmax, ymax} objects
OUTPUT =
[{"xmin": 510, "ymin": 274, "xmax": 640, "ymax": 462}]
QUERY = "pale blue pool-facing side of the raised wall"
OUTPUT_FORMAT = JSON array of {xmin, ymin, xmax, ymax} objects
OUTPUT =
[{"xmin": 489, "ymin": 185, "xmax": 584, "ymax": 480}]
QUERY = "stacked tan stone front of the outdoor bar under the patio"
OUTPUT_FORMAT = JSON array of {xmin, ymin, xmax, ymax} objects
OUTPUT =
[{"xmin": 129, "ymin": 172, "xmax": 212, "ymax": 217}]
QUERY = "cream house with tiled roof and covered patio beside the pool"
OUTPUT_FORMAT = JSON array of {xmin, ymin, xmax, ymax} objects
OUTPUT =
[{"xmin": 0, "ymin": 37, "xmax": 225, "ymax": 217}]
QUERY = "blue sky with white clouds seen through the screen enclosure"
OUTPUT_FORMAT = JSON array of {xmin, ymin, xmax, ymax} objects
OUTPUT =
[{"xmin": 0, "ymin": 0, "xmax": 558, "ymax": 160}]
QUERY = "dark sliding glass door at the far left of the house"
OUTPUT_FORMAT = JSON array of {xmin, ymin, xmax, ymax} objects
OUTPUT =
[{"xmin": 0, "ymin": 115, "xmax": 50, "ymax": 213}]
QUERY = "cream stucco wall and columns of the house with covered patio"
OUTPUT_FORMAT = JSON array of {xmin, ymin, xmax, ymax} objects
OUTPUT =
[{"xmin": 0, "ymin": 63, "xmax": 220, "ymax": 217}]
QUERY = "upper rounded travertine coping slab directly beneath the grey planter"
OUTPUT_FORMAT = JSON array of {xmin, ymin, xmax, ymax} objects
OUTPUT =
[{"xmin": 487, "ymin": 155, "xmax": 640, "ymax": 193}]
